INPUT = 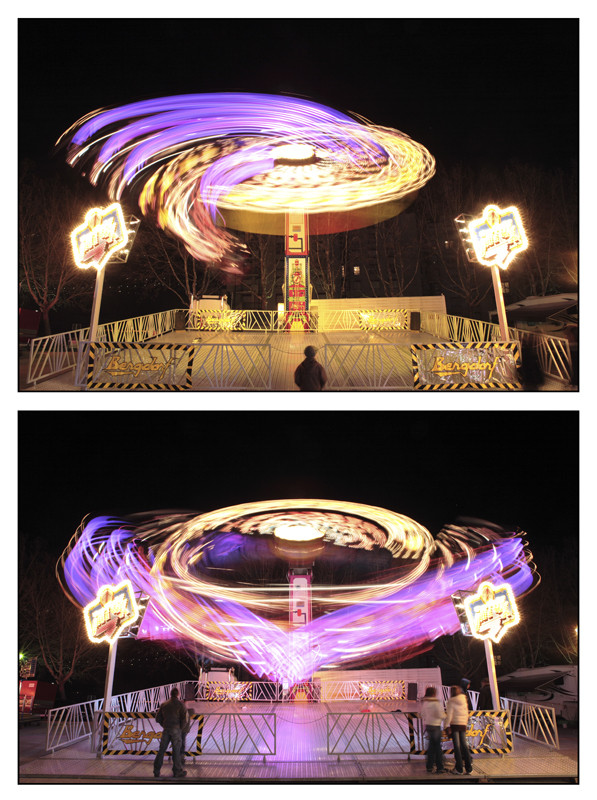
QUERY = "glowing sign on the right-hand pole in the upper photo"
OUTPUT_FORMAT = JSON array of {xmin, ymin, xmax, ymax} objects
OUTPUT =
[{"xmin": 468, "ymin": 205, "xmax": 528, "ymax": 269}]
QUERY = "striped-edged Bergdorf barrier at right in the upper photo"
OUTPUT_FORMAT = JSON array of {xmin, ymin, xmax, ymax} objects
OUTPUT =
[{"xmin": 411, "ymin": 342, "xmax": 522, "ymax": 392}]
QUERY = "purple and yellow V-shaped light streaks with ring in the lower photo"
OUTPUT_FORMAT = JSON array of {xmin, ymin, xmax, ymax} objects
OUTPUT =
[{"xmin": 58, "ymin": 500, "xmax": 533, "ymax": 683}]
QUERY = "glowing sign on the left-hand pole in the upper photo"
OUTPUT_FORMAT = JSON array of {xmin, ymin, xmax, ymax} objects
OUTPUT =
[{"xmin": 71, "ymin": 203, "xmax": 128, "ymax": 271}]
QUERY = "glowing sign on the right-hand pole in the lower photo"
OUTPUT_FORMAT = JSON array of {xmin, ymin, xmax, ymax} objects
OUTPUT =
[{"xmin": 462, "ymin": 582, "xmax": 520, "ymax": 643}]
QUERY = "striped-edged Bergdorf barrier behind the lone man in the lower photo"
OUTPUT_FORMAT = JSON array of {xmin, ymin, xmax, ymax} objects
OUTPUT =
[{"xmin": 102, "ymin": 711, "xmax": 205, "ymax": 756}]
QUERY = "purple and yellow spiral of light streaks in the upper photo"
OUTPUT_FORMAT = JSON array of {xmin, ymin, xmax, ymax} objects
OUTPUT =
[{"xmin": 57, "ymin": 93, "xmax": 435, "ymax": 270}]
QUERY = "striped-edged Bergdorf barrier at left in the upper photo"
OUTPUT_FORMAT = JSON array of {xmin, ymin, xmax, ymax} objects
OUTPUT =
[{"xmin": 87, "ymin": 342, "xmax": 195, "ymax": 392}]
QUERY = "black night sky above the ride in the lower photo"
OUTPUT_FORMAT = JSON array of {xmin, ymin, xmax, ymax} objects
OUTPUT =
[{"xmin": 19, "ymin": 410, "xmax": 578, "ymax": 556}]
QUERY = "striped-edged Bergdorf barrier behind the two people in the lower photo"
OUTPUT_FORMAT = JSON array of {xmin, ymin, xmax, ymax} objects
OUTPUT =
[{"xmin": 406, "ymin": 711, "xmax": 514, "ymax": 756}]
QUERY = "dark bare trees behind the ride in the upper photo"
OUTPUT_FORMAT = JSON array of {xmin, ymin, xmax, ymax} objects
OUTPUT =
[{"xmin": 19, "ymin": 162, "xmax": 578, "ymax": 333}]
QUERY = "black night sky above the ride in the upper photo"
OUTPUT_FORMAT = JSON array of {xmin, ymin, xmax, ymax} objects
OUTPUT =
[{"xmin": 18, "ymin": 17, "xmax": 578, "ymax": 169}]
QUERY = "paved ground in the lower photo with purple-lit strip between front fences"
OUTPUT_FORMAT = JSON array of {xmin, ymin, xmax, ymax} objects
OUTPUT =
[{"xmin": 19, "ymin": 704, "xmax": 578, "ymax": 784}]
